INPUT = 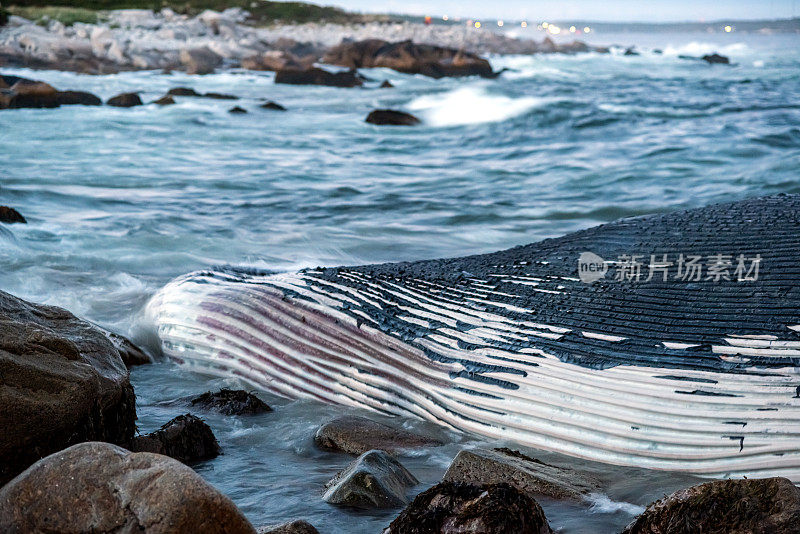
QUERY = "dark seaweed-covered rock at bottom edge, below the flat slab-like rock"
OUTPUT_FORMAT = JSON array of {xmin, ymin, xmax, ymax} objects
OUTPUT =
[{"xmin": 384, "ymin": 482, "xmax": 552, "ymax": 534}]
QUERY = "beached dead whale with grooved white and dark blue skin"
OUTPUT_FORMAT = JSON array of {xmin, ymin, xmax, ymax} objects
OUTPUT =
[{"xmin": 147, "ymin": 195, "xmax": 800, "ymax": 482}]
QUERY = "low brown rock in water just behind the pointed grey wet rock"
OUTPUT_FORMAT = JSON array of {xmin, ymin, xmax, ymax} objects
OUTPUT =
[{"xmin": 314, "ymin": 415, "xmax": 442, "ymax": 454}]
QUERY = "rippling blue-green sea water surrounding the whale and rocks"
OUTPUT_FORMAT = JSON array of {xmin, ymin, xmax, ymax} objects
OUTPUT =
[{"xmin": 0, "ymin": 33, "xmax": 800, "ymax": 533}]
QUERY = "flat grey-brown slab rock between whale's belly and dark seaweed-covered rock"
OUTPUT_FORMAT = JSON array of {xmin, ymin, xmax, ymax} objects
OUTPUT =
[{"xmin": 442, "ymin": 449, "xmax": 599, "ymax": 500}]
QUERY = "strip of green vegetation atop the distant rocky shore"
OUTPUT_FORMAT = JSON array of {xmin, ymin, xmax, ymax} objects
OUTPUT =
[{"xmin": 9, "ymin": 0, "xmax": 390, "ymax": 25}]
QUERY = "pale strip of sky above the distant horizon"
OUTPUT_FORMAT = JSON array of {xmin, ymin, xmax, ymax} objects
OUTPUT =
[{"xmin": 326, "ymin": 0, "xmax": 800, "ymax": 22}]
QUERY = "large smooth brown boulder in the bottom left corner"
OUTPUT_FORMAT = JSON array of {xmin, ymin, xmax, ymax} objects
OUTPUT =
[{"xmin": 0, "ymin": 442, "xmax": 255, "ymax": 534}]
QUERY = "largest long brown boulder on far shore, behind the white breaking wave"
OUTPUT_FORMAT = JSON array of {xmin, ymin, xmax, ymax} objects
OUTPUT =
[{"xmin": 322, "ymin": 39, "xmax": 497, "ymax": 78}]
